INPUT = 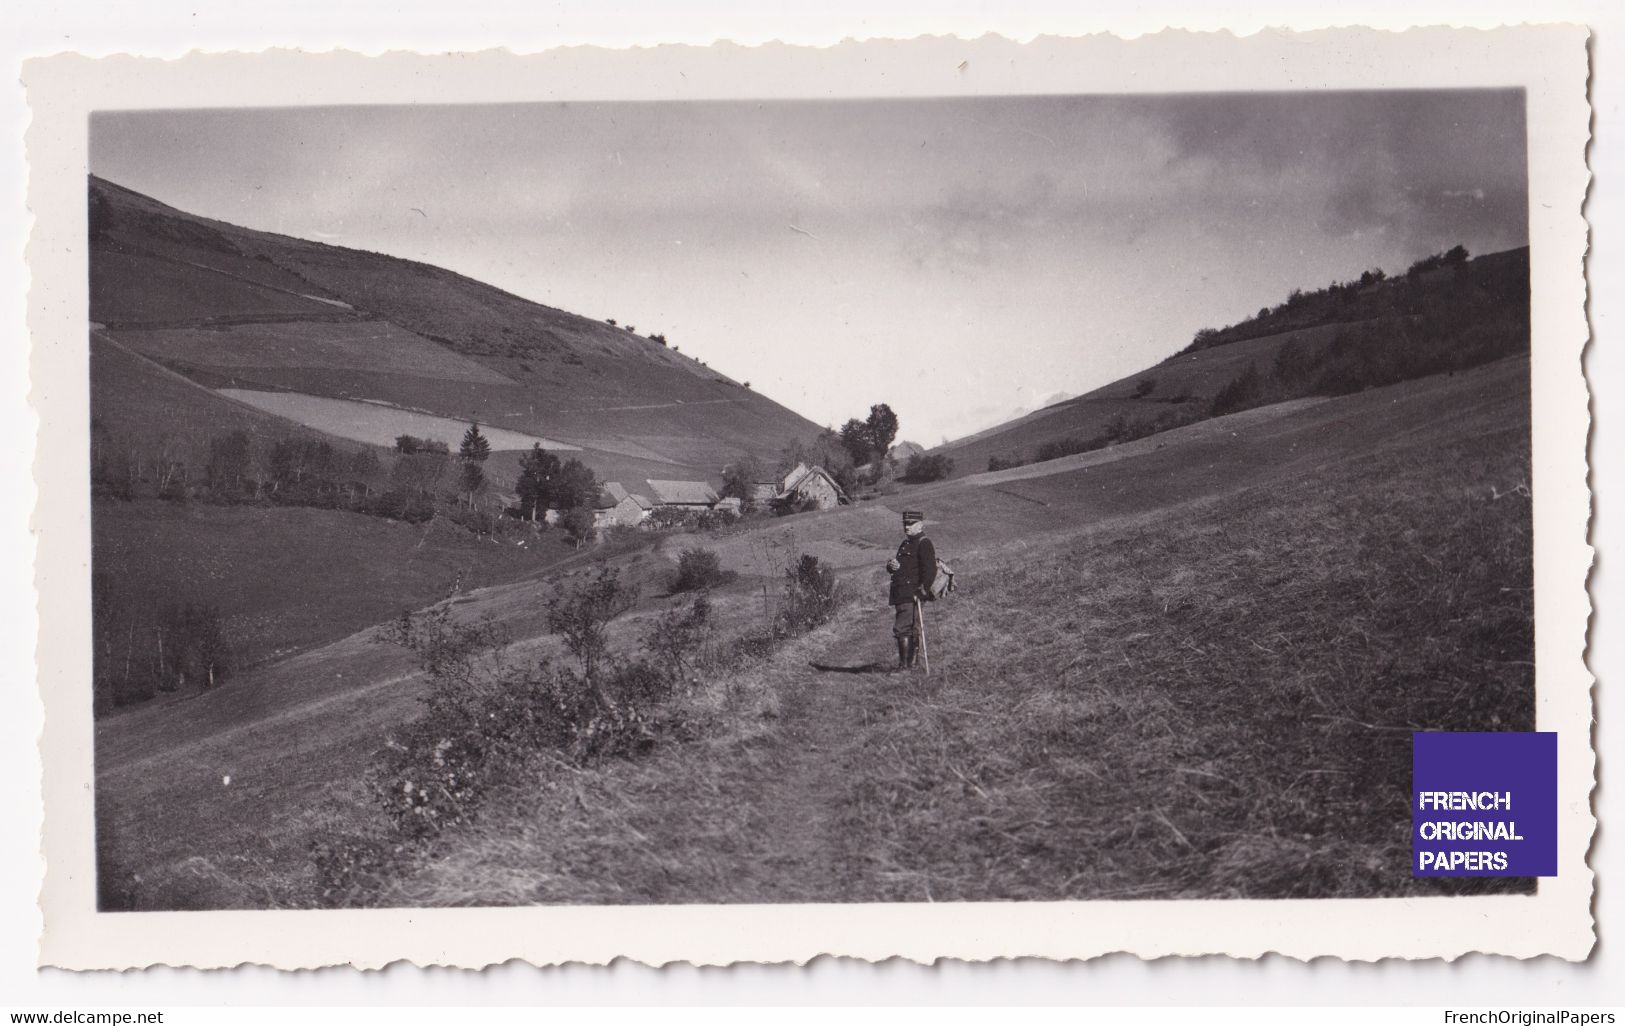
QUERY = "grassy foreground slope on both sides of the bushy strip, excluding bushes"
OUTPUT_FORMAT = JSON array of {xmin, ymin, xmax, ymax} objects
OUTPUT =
[{"xmin": 98, "ymin": 352, "xmax": 1534, "ymax": 907}]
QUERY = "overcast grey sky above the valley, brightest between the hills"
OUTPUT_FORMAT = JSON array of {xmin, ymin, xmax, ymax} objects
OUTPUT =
[{"xmin": 91, "ymin": 91, "xmax": 1528, "ymax": 444}]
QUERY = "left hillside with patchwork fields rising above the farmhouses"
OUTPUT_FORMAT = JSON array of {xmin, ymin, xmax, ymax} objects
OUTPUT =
[{"xmin": 89, "ymin": 177, "xmax": 817, "ymax": 476}]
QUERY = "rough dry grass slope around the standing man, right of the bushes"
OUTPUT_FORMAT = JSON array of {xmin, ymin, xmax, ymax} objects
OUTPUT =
[{"xmin": 349, "ymin": 393, "xmax": 1534, "ymax": 906}]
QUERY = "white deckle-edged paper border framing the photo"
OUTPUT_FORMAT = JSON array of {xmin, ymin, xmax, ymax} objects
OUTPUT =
[{"xmin": 24, "ymin": 26, "xmax": 1596, "ymax": 969}]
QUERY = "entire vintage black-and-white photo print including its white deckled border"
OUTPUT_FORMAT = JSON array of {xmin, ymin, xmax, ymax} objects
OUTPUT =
[{"xmin": 31, "ymin": 31, "xmax": 1591, "ymax": 967}]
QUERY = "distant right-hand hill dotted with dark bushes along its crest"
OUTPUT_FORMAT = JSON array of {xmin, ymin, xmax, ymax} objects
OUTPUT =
[{"xmin": 936, "ymin": 249, "xmax": 1529, "ymax": 475}]
